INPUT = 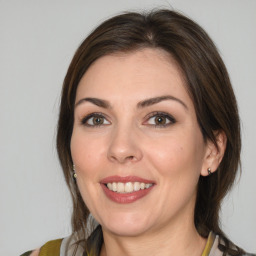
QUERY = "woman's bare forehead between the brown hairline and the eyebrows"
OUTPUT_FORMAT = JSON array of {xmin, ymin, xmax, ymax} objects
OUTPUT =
[{"xmin": 77, "ymin": 48, "xmax": 191, "ymax": 105}]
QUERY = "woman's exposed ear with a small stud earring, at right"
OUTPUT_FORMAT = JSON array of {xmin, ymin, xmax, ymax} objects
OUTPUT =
[{"xmin": 201, "ymin": 131, "xmax": 227, "ymax": 176}]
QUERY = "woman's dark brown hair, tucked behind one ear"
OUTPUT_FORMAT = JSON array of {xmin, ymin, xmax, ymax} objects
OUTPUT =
[{"xmin": 57, "ymin": 10, "xmax": 241, "ymax": 255}]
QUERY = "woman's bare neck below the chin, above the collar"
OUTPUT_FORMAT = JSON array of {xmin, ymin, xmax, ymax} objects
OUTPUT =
[{"xmin": 100, "ymin": 219, "xmax": 206, "ymax": 256}]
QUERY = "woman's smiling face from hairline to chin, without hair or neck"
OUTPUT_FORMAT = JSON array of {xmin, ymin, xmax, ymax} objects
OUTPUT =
[{"xmin": 71, "ymin": 49, "xmax": 209, "ymax": 236}]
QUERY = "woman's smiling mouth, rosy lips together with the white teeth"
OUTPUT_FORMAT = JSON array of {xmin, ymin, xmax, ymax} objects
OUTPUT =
[{"xmin": 100, "ymin": 176, "xmax": 156, "ymax": 204}]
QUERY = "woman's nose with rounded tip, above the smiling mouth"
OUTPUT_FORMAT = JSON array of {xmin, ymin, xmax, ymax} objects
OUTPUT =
[{"xmin": 108, "ymin": 124, "xmax": 143, "ymax": 164}]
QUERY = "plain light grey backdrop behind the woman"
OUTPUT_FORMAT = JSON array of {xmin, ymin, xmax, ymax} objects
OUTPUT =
[{"xmin": 0, "ymin": 0, "xmax": 256, "ymax": 256}]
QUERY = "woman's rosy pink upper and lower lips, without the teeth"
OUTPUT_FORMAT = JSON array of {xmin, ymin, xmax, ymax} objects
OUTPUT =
[{"xmin": 100, "ymin": 176, "xmax": 155, "ymax": 204}]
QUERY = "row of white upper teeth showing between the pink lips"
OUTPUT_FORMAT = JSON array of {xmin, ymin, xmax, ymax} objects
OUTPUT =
[{"xmin": 107, "ymin": 182, "xmax": 153, "ymax": 193}]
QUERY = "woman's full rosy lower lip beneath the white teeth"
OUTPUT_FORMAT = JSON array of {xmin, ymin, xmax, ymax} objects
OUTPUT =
[{"xmin": 101, "ymin": 184, "xmax": 154, "ymax": 204}]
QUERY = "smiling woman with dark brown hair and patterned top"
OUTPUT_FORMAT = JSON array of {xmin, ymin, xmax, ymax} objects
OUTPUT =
[{"xmin": 21, "ymin": 10, "xmax": 254, "ymax": 256}]
